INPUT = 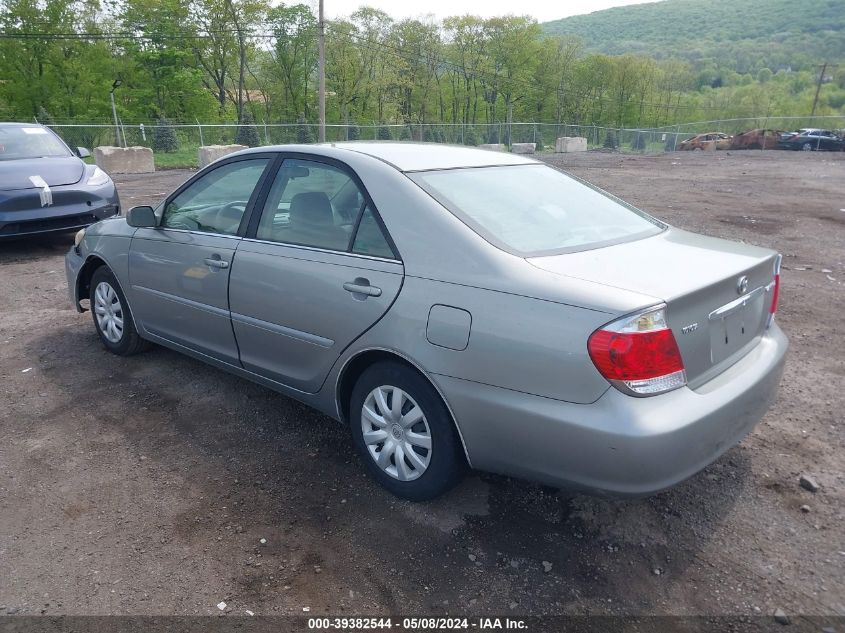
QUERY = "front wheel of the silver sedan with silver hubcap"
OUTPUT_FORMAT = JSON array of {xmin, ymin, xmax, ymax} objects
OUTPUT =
[{"xmin": 90, "ymin": 266, "xmax": 148, "ymax": 356}]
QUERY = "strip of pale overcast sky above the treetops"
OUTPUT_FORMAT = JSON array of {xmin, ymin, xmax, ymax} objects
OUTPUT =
[{"xmin": 320, "ymin": 0, "xmax": 656, "ymax": 22}]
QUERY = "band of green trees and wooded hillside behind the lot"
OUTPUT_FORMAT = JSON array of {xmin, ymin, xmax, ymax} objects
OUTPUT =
[{"xmin": 0, "ymin": 0, "xmax": 845, "ymax": 133}]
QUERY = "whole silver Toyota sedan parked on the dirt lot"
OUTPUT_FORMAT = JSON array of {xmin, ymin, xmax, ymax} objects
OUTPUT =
[{"xmin": 66, "ymin": 143, "xmax": 787, "ymax": 499}]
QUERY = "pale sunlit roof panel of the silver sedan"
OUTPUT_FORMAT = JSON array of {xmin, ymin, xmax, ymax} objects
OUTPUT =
[{"xmin": 324, "ymin": 141, "xmax": 538, "ymax": 172}]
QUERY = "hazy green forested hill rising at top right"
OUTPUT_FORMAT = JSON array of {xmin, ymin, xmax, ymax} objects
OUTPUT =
[{"xmin": 543, "ymin": 0, "xmax": 845, "ymax": 73}]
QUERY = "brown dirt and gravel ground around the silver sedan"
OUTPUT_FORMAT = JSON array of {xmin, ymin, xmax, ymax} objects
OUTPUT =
[{"xmin": 0, "ymin": 151, "xmax": 845, "ymax": 630}]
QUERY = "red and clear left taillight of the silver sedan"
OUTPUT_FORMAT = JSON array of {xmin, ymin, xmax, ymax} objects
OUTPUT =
[{"xmin": 587, "ymin": 306, "xmax": 687, "ymax": 396}]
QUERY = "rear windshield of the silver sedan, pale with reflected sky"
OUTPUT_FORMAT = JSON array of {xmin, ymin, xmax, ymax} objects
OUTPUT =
[{"xmin": 409, "ymin": 165, "xmax": 666, "ymax": 257}]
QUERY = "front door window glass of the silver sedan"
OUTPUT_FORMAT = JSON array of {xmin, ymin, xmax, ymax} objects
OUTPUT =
[{"xmin": 161, "ymin": 158, "xmax": 269, "ymax": 235}]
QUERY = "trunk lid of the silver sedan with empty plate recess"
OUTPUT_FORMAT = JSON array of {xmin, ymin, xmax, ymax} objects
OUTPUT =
[{"xmin": 528, "ymin": 228, "xmax": 777, "ymax": 388}]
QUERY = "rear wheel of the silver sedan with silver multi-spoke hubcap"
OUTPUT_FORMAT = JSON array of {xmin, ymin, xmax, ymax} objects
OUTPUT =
[{"xmin": 349, "ymin": 362, "xmax": 465, "ymax": 501}]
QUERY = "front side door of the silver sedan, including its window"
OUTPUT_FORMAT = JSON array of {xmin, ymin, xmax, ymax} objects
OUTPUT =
[{"xmin": 129, "ymin": 155, "xmax": 272, "ymax": 365}]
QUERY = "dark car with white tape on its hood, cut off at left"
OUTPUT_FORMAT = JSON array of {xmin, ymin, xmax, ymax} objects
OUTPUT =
[{"xmin": 0, "ymin": 123, "xmax": 120, "ymax": 238}]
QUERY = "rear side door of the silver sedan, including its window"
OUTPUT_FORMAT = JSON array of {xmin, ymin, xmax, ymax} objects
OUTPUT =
[{"xmin": 229, "ymin": 157, "xmax": 404, "ymax": 393}]
